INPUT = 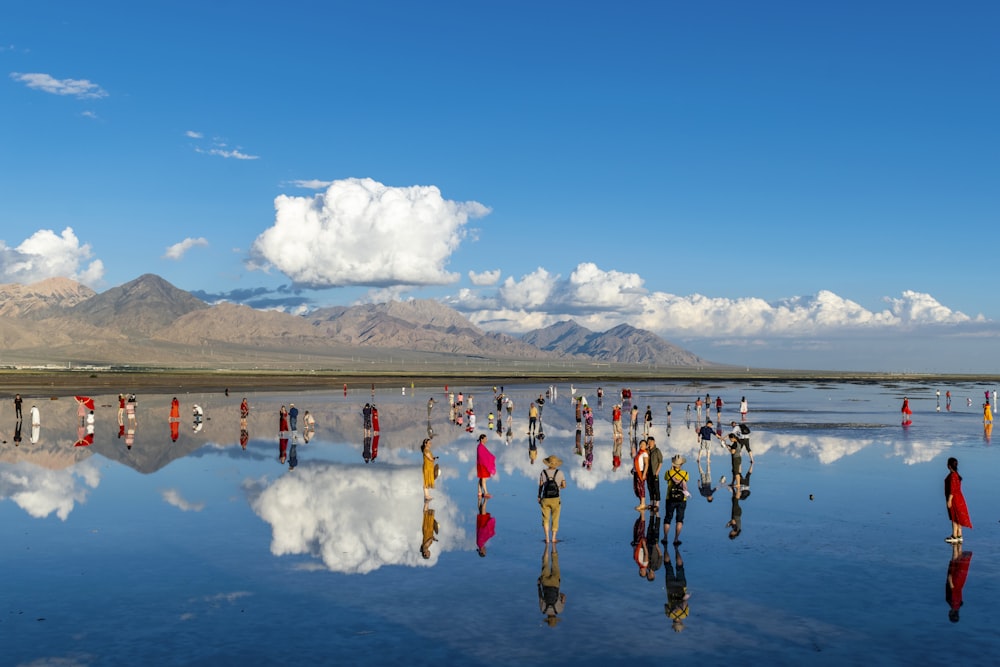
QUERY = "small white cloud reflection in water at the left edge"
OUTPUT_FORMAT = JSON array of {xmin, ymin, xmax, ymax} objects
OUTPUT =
[{"xmin": 0, "ymin": 461, "xmax": 100, "ymax": 521}]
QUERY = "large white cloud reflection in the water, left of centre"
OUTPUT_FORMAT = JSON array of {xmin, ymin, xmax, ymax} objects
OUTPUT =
[{"xmin": 245, "ymin": 463, "xmax": 466, "ymax": 574}]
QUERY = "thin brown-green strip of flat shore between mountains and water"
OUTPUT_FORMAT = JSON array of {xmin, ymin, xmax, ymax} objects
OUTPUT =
[{"xmin": 0, "ymin": 366, "xmax": 1000, "ymax": 396}]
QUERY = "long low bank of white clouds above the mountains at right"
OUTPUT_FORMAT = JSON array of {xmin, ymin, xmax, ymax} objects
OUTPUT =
[{"xmin": 446, "ymin": 262, "xmax": 981, "ymax": 338}]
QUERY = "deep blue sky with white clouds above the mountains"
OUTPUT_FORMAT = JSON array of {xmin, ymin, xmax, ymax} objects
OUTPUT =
[{"xmin": 0, "ymin": 0, "xmax": 1000, "ymax": 372}]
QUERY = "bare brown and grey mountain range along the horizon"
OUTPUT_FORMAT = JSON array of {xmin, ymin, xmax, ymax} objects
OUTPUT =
[{"xmin": 0, "ymin": 274, "xmax": 712, "ymax": 368}]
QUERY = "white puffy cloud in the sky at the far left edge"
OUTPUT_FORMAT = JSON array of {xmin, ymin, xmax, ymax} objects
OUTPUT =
[{"xmin": 0, "ymin": 227, "xmax": 104, "ymax": 285}]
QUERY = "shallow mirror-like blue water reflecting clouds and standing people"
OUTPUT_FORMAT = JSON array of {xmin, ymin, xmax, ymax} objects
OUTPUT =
[{"xmin": 0, "ymin": 382, "xmax": 1000, "ymax": 665}]
